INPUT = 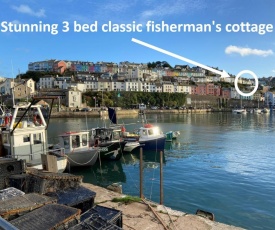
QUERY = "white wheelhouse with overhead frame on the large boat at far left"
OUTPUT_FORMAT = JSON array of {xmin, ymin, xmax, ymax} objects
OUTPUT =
[{"xmin": 0, "ymin": 105, "xmax": 47, "ymax": 163}]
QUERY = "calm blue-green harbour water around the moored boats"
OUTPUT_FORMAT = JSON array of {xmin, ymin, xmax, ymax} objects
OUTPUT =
[{"xmin": 48, "ymin": 113, "xmax": 275, "ymax": 229}]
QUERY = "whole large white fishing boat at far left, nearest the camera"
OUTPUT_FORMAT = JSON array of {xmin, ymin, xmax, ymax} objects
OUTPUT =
[{"xmin": 0, "ymin": 97, "xmax": 67, "ymax": 172}]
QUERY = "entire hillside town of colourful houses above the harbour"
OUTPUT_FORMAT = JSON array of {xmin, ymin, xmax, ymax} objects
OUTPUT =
[{"xmin": 0, "ymin": 59, "xmax": 275, "ymax": 107}]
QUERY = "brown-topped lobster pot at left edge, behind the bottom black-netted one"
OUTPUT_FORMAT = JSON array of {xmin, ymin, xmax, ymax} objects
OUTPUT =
[{"xmin": 0, "ymin": 193, "xmax": 56, "ymax": 220}]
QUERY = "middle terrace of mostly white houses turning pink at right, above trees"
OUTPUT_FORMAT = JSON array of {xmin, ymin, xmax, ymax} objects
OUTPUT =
[{"xmin": 39, "ymin": 75, "xmax": 260, "ymax": 100}]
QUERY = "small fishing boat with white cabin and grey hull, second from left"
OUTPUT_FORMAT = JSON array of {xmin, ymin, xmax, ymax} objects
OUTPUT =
[{"xmin": 51, "ymin": 131, "xmax": 99, "ymax": 168}]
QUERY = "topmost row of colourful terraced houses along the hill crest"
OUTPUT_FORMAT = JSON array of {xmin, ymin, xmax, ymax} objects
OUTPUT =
[{"xmin": 28, "ymin": 59, "xmax": 252, "ymax": 84}]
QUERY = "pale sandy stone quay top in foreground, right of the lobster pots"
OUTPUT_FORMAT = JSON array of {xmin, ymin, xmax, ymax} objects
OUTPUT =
[{"xmin": 83, "ymin": 183, "xmax": 245, "ymax": 230}]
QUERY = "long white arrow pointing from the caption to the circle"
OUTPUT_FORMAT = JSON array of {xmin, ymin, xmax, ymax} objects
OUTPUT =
[{"xmin": 132, "ymin": 38, "xmax": 230, "ymax": 78}]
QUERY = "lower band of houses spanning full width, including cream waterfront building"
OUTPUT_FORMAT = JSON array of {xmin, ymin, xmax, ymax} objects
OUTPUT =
[{"xmin": 0, "ymin": 76, "xmax": 275, "ymax": 107}]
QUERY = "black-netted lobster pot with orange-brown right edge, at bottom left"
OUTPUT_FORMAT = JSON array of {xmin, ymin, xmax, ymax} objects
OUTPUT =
[{"xmin": 10, "ymin": 204, "xmax": 80, "ymax": 230}]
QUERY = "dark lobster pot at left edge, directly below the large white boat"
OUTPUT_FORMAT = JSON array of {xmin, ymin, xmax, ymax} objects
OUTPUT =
[{"xmin": 0, "ymin": 158, "xmax": 26, "ymax": 189}]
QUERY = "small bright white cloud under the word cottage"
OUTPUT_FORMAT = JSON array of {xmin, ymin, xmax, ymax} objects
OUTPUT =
[{"xmin": 225, "ymin": 45, "xmax": 273, "ymax": 57}]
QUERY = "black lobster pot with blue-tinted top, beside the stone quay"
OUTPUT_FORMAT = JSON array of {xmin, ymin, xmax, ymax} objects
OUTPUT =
[{"xmin": 47, "ymin": 186, "xmax": 96, "ymax": 212}]
